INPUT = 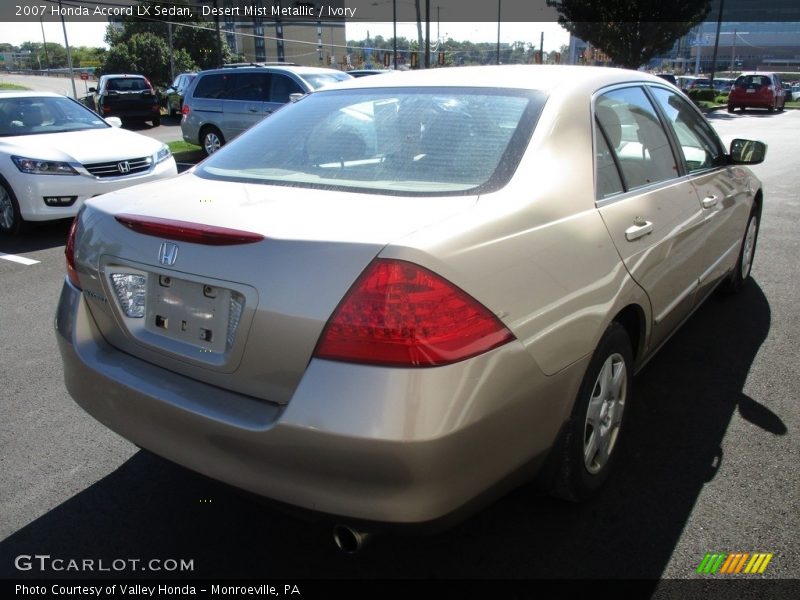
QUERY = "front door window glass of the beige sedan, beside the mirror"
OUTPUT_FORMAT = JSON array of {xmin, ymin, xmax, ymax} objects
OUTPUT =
[{"xmin": 651, "ymin": 87, "xmax": 725, "ymax": 173}]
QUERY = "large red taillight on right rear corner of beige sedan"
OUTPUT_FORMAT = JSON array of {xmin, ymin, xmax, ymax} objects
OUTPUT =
[{"xmin": 315, "ymin": 259, "xmax": 514, "ymax": 367}]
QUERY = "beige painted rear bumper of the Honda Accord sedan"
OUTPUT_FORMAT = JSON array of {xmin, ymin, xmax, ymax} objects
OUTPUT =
[{"xmin": 55, "ymin": 282, "xmax": 586, "ymax": 526}]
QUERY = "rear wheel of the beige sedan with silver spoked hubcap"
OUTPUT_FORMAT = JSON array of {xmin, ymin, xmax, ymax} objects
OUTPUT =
[{"xmin": 552, "ymin": 322, "xmax": 633, "ymax": 502}]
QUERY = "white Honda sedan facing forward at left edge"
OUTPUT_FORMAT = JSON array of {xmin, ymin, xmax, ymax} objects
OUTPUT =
[{"xmin": 0, "ymin": 91, "xmax": 177, "ymax": 235}]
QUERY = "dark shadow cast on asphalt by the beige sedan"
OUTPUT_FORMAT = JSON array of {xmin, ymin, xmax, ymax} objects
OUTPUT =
[{"xmin": 0, "ymin": 282, "xmax": 786, "ymax": 580}]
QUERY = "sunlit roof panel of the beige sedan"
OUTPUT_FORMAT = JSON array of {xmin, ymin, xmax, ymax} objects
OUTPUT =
[{"xmin": 324, "ymin": 65, "xmax": 668, "ymax": 92}]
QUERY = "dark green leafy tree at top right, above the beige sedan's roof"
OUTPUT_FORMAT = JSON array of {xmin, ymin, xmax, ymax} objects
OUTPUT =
[{"xmin": 547, "ymin": 0, "xmax": 710, "ymax": 69}]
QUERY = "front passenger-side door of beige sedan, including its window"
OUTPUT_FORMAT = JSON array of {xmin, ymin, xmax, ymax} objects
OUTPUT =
[{"xmin": 650, "ymin": 86, "xmax": 749, "ymax": 298}]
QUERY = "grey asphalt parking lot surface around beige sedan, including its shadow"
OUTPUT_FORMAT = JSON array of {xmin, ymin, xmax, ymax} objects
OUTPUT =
[{"xmin": 0, "ymin": 75, "xmax": 800, "ymax": 598}]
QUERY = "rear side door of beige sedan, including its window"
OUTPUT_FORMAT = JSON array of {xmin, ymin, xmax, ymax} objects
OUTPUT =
[{"xmin": 594, "ymin": 86, "xmax": 705, "ymax": 347}]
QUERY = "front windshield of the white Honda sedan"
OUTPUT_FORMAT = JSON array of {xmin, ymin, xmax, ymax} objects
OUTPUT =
[{"xmin": 0, "ymin": 96, "xmax": 109, "ymax": 136}]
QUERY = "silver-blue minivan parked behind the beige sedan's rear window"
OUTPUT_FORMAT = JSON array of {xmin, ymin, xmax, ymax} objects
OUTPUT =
[{"xmin": 186, "ymin": 64, "xmax": 352, "ymax": 154}]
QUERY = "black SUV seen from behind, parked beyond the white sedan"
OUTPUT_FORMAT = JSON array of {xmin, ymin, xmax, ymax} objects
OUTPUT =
[{"xmin": 89, "ymin": 74, "xmax": 161, "ymax": 127}]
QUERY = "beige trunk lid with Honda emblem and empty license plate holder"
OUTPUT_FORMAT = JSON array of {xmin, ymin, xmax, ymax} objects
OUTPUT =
[{"xmin": 75, "ymin": 173, "xmax": 476, "ymax": 403}]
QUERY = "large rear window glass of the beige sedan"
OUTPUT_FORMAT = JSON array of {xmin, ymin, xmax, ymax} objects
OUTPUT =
[{"xmin": 196, "ymin": 88, "xmax": 544, "ymax": 195}]
